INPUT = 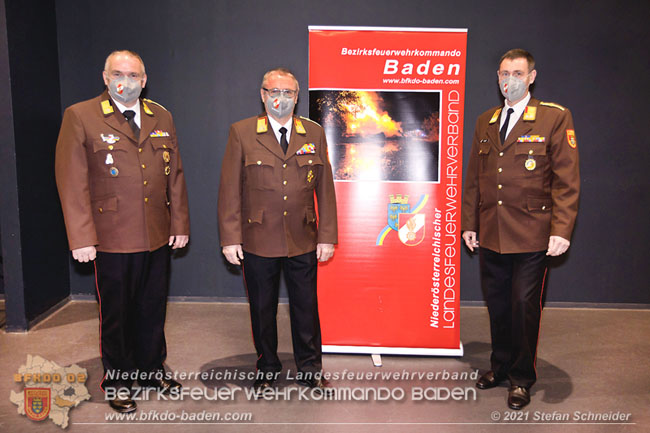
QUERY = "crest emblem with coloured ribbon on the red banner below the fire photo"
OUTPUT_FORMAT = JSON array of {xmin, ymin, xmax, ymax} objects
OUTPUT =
[{"xmin": 376, "ymin": 194, "xmax": 429, "ymax": 247}]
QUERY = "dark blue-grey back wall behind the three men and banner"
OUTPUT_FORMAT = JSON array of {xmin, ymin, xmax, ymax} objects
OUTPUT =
[{"xmin": 3, "ymin": 0, "xmax": 650, "ymax": 304}]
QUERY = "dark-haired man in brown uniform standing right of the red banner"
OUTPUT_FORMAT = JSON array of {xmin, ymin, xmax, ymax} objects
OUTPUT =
[{"xmin": 461, "ymin": 49, "xmax": 580, "ymax": 409}]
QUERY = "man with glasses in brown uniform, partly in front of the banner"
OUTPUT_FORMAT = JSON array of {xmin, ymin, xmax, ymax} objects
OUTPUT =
[{"xmin": 218, "ymin": 68, "xmax": 337, "ymax": 392}]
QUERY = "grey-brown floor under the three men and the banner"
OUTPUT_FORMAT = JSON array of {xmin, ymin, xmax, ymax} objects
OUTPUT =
[{"xmin": 0, "ymin": 302, "xmax": 650, "ymax": 433}]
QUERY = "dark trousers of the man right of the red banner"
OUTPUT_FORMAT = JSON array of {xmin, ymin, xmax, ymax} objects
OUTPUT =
[{"xmin": 479, "ymin": 248, "xmax": 547, "ymax": 388}]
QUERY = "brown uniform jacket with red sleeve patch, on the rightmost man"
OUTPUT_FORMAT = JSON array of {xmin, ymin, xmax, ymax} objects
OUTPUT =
[{"xmin": 461, "ymin": 98, "xmax": 580, "ymax": 253}]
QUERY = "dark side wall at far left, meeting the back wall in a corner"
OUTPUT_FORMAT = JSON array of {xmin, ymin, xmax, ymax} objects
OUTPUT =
[{"xmin": 0, "ymin": 0, "xmax": 70, "ymax": 330}]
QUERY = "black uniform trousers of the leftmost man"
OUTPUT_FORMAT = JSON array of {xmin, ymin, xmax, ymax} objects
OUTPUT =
[{"xmin": 95, "ymin": 245, "xmax": 169, "ymax": 389}]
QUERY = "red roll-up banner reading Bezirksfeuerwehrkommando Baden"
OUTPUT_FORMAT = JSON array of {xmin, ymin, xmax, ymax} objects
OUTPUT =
[{"xmin": 309, "ymin": 26, "xmax": 467, "ymax": 356}]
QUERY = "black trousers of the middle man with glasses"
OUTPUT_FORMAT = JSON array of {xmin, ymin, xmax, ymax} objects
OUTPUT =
[{"xmin": 243, "ymin": 252, "xmax": 322, "ymax": 373}]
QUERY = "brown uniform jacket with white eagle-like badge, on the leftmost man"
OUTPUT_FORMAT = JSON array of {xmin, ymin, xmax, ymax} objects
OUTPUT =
[{"xmin": 56, "ymin": 92, "xmax": 190, "ymax": 253}]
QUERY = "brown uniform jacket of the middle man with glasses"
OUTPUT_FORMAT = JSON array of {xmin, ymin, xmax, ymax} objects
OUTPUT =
[{"xmin": 218, "ymin": 116, "xmax": 337, "ymax": 257}]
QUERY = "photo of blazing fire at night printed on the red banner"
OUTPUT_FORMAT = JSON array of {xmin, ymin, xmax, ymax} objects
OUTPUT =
[{"xmin": 310, "ymin": 90, "xmax": 440, "ymax": 181}]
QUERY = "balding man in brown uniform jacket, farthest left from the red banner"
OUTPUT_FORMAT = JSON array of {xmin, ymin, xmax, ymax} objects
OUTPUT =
[{"xmin": 56, "ymin": 51, "xmax": 190, "ymax": 412}]
